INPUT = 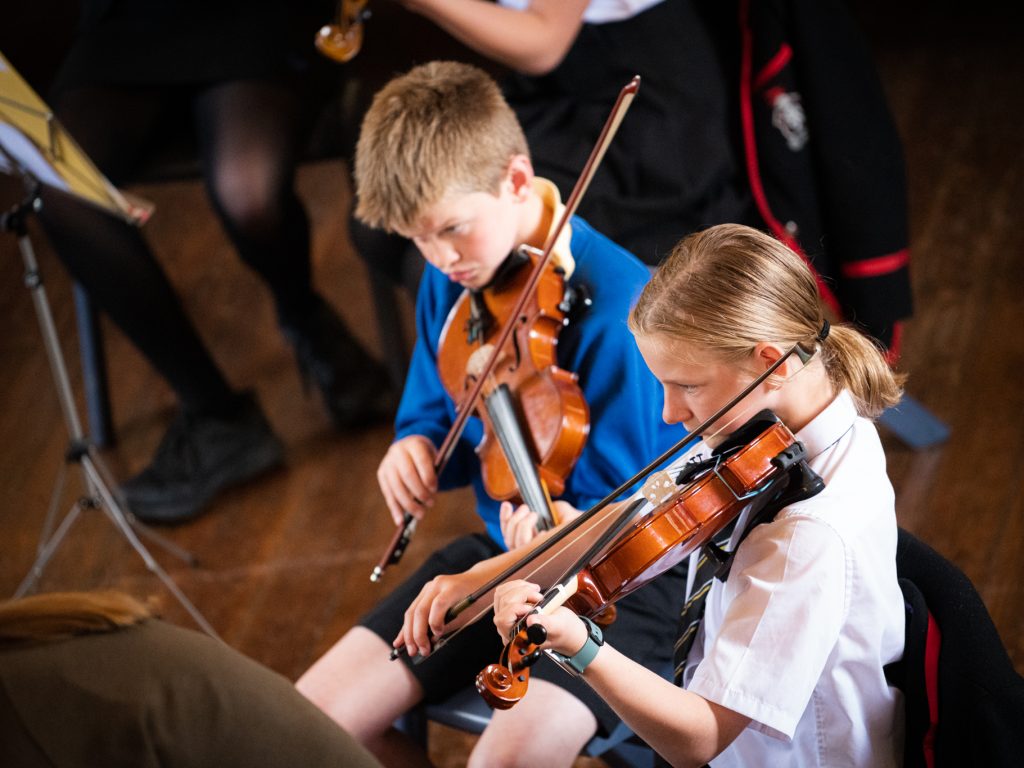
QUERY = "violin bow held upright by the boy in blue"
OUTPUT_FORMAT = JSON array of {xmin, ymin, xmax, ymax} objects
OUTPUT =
[{"xmin": 370, "ymin": 75, "xmax": 640, "ymax": 582}]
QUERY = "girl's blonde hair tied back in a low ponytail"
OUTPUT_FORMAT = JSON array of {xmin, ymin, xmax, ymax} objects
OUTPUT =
[{"xmin": 630, "ymin": 224, "xmax": 903, "ymax": 419}]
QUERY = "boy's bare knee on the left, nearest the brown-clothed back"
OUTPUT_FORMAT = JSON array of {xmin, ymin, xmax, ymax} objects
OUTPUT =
[{"xmin": 295, "ymin": 627, "xmax": 430, "ymax": 766}]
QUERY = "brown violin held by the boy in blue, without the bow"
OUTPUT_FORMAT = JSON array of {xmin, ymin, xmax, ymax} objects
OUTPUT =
[{"xmin": 437, "ymin": 248, "xmax": 590, "ymax": 530}]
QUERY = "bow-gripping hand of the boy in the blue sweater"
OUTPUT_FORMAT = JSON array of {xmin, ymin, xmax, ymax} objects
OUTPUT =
[{"xmin": 377, "ymin": 434, "xmax": 437, "ymax": 525}]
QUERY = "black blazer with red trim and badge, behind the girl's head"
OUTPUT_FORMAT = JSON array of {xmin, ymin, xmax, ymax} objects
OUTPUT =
[{"xmin": 739, "ymin": 0, "xmax": 912, "ymax": 356}]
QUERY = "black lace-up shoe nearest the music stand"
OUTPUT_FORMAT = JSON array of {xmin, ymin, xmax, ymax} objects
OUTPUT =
[{"xmin": 121, "ymin": 393, "xmax": 285, "ymax": 524}]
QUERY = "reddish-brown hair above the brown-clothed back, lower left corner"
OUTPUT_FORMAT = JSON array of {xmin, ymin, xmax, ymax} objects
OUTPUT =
[{"xmin": 0, "ymin": 591, "xmax": 153, "ymax": 647}]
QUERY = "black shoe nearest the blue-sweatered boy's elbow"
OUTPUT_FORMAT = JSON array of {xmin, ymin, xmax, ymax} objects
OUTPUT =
[{"xmin": 281, "ymin": 297, "xmax": 395, "ymax": 430}]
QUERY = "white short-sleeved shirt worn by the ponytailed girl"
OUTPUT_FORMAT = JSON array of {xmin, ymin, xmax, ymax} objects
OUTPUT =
[{"xmin": 683, "ymin": 392, "xmax": 904, "ymax": 768}]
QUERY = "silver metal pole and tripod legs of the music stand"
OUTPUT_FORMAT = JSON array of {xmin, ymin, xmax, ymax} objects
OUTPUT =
[{"xmin": 0, "ymin": 188, "xmax": 218, "ymax": 638}]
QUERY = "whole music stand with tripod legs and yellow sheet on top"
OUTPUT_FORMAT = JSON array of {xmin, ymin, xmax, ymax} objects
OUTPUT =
[{"xmin": 0, "ymin": 49, "xmax": 218, "ymax": 638}]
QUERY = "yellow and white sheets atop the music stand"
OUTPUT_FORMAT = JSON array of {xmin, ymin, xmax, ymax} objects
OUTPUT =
[{"xmin": 0, "ymin": 53, "xmax": 153, "ymax": 223}]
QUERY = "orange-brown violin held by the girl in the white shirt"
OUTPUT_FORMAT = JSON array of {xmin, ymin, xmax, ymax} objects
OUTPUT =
[{"xmin": 476, "ymin": 412, "xmax": 824, "ymax": 710}]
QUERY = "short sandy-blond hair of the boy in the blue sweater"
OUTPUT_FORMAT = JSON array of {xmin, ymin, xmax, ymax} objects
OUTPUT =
[{"xmin": 355, "ymin": 61, "xmax": 529, "ymax": 232}]
